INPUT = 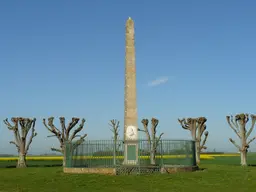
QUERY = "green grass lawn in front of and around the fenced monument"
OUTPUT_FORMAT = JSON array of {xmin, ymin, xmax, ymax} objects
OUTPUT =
[{"xmin": 0, "ymin": 157, "xmax": 256, "ymax": 192}]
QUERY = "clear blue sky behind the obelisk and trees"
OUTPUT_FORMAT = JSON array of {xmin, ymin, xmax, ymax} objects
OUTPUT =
[{"xmin": 0, "ymin": 0, "xmax": 256, "ymax": 153}]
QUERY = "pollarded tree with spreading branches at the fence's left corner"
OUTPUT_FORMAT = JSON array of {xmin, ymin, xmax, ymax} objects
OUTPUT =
[{"xmin": 43, "ymin": 117, "xmax": 87, "ymax": 167}]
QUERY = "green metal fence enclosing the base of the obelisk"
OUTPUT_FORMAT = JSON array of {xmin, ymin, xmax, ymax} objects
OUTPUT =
[{"xmin": 66, "ymin": 140, "xmax": 196, "ymax": 174}]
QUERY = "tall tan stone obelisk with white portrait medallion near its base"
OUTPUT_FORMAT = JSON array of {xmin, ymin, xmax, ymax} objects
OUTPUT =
[{"xmin": 124, "ymin": 17, "xmax": 138, "ymax": 164}]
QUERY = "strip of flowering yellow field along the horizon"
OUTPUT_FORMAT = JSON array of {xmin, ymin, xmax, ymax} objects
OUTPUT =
[{"xmin": 0, "ymin": 153, "xmax": 240, "ymax": 161}]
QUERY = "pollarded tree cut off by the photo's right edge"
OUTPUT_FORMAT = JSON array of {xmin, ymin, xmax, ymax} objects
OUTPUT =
[{"xmin": 226, "ymin": 113, "xmax": 256, "ymax": 166}]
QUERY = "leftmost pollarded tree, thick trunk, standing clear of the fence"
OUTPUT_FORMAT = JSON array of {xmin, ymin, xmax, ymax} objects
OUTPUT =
[{"xmin": 4, "ymin": 117, "xmax": 37, "ymax": 168}]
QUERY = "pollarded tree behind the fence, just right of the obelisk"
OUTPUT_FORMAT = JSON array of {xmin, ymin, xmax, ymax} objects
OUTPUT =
[{"xmin": 138, "ymin": 118, "xmax": 164, "ymax": 165}]
